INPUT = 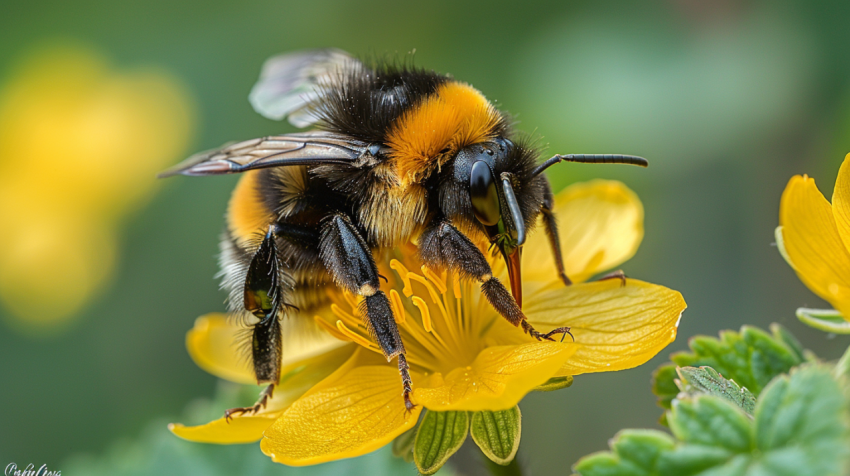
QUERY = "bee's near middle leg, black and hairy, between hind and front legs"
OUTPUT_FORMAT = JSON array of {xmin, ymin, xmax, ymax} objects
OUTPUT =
[{"xmin": 319, "ymin": 214, "xmax": 415, "ymax": 411}]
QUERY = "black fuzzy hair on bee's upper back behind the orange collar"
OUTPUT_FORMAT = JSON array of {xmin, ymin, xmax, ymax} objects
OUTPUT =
[{"xmin": 314, "ymin": 61, "xmax": 449, "ymax": 143}]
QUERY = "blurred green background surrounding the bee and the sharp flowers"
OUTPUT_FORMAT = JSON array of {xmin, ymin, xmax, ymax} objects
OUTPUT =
[{"xmin": 0, "ymin": 0, "xmax": 850, "ymax": 474}]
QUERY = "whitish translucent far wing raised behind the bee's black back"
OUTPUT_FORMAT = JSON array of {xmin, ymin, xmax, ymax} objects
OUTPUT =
[{"xmin": 248, "ymin": 49, "xmax": 360, "ymax": 127}]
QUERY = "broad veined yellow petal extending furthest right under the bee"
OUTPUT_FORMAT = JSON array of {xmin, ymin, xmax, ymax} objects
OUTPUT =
[{"xmin": 523, "ymin": 279, "xmax": 687, "ymax": 375}]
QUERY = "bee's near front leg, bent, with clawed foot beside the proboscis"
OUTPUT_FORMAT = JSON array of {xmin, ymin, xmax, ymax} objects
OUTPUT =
[{"xmin": 419, "ymin": 219, "xmax": 572, "ymax": 340}]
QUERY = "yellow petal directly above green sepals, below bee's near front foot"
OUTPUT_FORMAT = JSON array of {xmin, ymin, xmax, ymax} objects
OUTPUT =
[{"xmin": 413, "ymin": 342, "xmax": 578, "ymax": 411}]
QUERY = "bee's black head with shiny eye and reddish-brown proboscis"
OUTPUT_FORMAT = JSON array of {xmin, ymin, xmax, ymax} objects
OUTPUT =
[{"xmin": 440, "ymin": 138, "xmax": 544, "ymax": 303}]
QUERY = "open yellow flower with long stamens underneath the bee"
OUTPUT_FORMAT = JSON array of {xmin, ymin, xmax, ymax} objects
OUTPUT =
[{"xmin": 171, "ymin": 181, "xmax": 685, "ymax": 466}]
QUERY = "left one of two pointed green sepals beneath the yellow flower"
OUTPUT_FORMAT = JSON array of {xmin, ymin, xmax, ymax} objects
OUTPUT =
[{"xmin": 413, "ymin": 410, "xmax": 469, "ymax": 474}]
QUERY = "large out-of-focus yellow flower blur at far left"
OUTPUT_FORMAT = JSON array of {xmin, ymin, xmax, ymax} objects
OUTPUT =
[{"xmin": 0, "ymin": 42, "xmax": 194, "ymax": 329}]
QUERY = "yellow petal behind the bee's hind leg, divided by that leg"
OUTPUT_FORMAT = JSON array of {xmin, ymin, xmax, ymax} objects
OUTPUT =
[{"xmin": 186, "ymin": 313, "xmax": 346, "ymax": 383}]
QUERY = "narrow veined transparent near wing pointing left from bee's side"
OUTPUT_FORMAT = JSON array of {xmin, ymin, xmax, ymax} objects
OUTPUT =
[{"xmin": 159, "ymin": 131, "xmax": 376, "ymax": 178}]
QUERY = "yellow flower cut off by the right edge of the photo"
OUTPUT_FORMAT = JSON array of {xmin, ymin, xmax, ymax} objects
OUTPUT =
[{"xmin": 776, "ymin": 154, "xmax": 850, "ymax": 333}]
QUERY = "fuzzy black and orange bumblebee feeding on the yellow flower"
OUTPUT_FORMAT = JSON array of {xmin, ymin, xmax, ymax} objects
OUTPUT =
[{"xmin": 161, "ymin": 50, "xmax": 647, "ymax": 416}]
